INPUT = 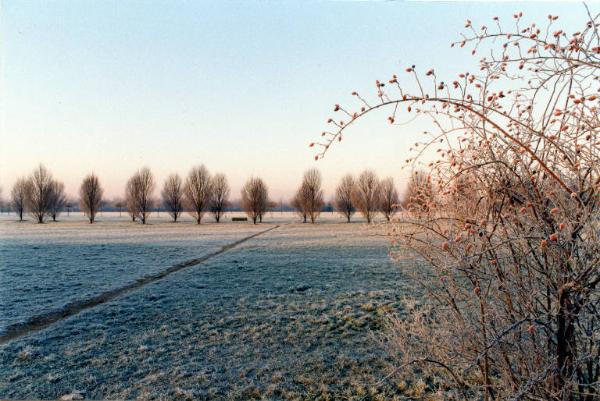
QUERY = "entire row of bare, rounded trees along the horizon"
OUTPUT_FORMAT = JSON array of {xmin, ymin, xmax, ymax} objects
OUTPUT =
[{"xmin": 3, "ymin": 165, "xmax": 426, "ymax": 224}]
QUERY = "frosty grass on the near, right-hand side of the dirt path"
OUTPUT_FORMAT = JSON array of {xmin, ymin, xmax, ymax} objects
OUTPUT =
[{"xmin": 0, "ymin": 216, "xmax": 418, "ymax": 400}]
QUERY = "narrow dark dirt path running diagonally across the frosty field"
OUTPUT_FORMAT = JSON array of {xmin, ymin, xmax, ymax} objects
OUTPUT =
[{"xmin": 0, "ymin": 225, "xmax": 280, "ymax": 345}]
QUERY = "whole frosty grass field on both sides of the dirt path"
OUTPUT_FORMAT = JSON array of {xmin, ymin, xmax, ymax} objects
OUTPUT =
[{"xmin": 0, "ymin": 213, "xmax": 418, "ymax": 400}]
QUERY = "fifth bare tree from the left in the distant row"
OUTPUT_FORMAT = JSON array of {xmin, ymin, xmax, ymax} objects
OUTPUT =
[{"xmin": 127, "ymin": 167, "xmax": 154, "ymax": 224}]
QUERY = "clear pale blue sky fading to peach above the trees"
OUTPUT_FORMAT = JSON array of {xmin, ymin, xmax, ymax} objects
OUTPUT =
[{"xmin": 0, "ymin": 0, "xmax": 600, "ymax": 200}]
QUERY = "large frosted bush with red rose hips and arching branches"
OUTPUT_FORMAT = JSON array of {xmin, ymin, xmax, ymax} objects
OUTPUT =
[{"xmin": 317, "ymin": 8, "xmax": 600, "ymax": 401}]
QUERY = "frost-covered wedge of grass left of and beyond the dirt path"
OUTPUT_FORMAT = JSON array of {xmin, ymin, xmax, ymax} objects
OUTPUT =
[{"xmin": 0, "ymin": 214, "xmax": 264, "ymax": 335}]
